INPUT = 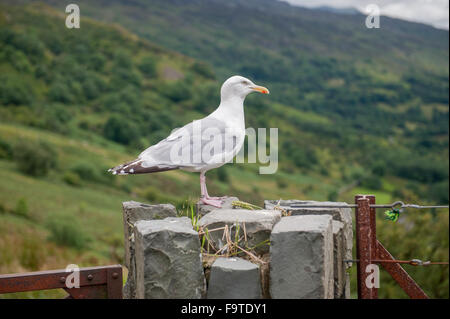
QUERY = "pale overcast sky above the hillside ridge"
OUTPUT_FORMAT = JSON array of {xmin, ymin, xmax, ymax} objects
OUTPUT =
[{"xmin": 281, "ymin": 0, "xmax": 449, "ymax": 30}]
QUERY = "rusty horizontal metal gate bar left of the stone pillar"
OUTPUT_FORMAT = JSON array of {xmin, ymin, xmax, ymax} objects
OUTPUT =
[{"xmin": 0, "ymin": 265, "xmax": 122, "ymax": 299}]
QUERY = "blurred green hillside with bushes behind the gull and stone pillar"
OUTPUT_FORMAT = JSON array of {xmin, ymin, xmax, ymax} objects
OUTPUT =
[{"xmin": 0, "ymin": 0, "xmax": 448, "ymax": 297}]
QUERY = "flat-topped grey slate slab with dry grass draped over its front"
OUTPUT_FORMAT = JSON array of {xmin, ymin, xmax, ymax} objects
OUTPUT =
[{"xmin": 199, "ymin": 209, "xmax": 281, "ymax": 253}]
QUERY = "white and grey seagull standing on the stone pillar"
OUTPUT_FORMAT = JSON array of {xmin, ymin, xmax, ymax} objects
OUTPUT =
[{"xmin": 108, "ymin": 75, "xmax": 269, "ymax": 208}]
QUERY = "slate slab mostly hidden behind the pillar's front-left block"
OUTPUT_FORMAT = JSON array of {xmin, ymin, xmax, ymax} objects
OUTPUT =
[{"xmin": 122, "ymin": 201, "xmax": 177, "ymax": 299}]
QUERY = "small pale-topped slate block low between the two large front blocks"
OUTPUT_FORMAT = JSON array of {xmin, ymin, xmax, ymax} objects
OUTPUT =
[{"xmin": 208, "ymin": 258, "xmax": 261, "ymax": 299}]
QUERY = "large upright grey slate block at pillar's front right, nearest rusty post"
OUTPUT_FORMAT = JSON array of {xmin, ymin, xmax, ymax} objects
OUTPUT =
[{"xmin": 270, "ymin": 215, "xmax": 334, "ymax": 299}]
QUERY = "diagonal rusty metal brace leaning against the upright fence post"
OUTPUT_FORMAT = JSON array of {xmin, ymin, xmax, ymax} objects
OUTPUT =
[{"xmin": 377, "ymin": 240, "xmax": 429, "ymax": 299}]
